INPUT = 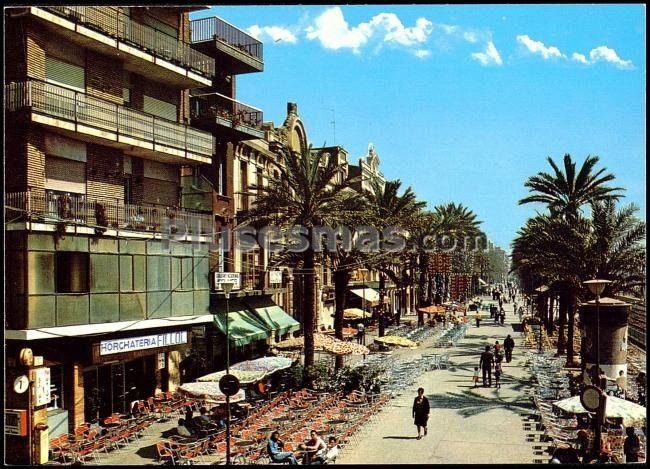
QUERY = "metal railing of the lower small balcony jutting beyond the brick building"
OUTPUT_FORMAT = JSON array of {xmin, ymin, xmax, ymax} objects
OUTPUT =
[{"xmin": 190, "ymin": 93, "xmax": 264, "ymax": 132}]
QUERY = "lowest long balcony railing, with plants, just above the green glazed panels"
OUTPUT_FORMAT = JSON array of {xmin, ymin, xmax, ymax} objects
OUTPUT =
[{"xmin": 5, "ymin": 190, "xmax": 213, "ymax": 236}]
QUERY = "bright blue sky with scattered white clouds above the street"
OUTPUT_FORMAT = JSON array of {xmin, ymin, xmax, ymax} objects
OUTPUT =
[{"xmin": 191, "ymin": 5, "xmax": 646, "ymax": 249}]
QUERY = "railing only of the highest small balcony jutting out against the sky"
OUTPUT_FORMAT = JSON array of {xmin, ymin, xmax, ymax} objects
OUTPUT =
[{"xmin": 190, "ymin": 16, "xmax": 263, "ymax": 61}]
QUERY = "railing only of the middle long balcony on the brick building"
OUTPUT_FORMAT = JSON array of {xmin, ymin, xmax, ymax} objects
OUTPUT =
[{"xmin": 5, "ymin": 80, "xmax": 213, "ymax": 156}]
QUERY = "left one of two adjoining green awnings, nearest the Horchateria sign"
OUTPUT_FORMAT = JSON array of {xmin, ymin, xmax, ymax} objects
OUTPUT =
[{"xmin": 211, "ymin": 299, "xmax": 271, "ymax": 346}]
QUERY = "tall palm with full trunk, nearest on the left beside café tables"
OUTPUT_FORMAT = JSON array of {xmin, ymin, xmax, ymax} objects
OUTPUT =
[{"xmin": 244, "ymin": 146, "xmax": 360, "ymax": 381}]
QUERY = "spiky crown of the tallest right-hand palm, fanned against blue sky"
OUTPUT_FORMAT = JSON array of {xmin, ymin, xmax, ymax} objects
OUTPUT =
[{"xmin": 519, "ymin": 153, "xmax": 625, "ymax": 218}]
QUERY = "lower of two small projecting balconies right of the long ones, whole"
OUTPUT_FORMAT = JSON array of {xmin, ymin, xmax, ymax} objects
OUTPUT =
[{"xmin": 190, "ymin": 93, "xmax": 264, "ymax": 140}]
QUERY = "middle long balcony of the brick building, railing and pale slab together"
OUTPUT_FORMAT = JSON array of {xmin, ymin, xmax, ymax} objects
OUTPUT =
[{"xmin": 5, "ymin": 80, "xmax": 214, "ymax": 163}]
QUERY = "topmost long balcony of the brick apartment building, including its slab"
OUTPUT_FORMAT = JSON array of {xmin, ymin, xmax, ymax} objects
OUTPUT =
[{"xmin": 29, "ymin": 6, "xmax": 215, "ymax": 88}]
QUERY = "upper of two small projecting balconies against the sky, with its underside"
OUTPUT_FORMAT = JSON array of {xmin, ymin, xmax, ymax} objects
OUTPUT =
[{"xmin": 190, "ymin": 16, "xmax": 264, "ymax": 75}]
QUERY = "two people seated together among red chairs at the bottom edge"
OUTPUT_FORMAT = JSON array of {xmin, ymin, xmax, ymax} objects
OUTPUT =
[{"xmin": 266, "ymin": 430, "xmax": 339, "ymax": 465}]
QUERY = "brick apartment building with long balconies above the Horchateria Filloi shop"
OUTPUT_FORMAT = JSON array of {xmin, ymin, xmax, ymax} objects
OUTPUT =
[{"xmin": 4, "ymin": 6, "xmax": 280, "ymax": 463}]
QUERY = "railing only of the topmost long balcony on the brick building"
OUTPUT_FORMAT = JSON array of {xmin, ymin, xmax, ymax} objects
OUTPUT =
[{"xmin": 42, "ymin": 6, "xmax": 215, "ymax": 77}]
